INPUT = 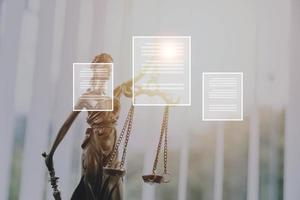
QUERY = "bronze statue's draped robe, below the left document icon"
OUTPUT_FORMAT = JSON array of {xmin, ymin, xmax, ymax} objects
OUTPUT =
[{"xmin": 71, "ymin": 98, "xmax": 123, "ymax": 200}]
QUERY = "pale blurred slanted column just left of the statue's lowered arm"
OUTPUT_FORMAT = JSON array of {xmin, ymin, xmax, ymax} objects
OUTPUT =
[{"xmin": 20, "ymin": 0, "xmax": 55, "ymax": 199}]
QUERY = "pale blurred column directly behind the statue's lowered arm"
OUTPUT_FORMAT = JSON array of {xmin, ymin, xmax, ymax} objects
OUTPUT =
[{"xmin": 48, "ymin": 0, "xmax": 84, "ymax": 199}]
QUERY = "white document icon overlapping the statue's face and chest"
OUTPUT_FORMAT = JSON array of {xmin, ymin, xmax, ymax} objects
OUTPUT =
[{"xmin": 73, "ymin": 63, "xmax": 113, "ymax": 111}]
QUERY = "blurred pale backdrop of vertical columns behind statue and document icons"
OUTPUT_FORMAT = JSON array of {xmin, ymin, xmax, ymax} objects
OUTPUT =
[{"xmin": 0, "ymin": 0, "xmax": 300, "ymax": 200}]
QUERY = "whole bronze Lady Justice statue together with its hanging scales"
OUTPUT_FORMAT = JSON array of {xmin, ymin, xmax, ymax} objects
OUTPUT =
[{"xmin": 42, "ymin": 54, "xmax": 179, "ymax": 200}]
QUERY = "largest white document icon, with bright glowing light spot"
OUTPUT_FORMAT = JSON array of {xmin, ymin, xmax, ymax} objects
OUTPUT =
[{"xmin": 132, "ymin": 36, "xmax": 191, "ymax": 106}]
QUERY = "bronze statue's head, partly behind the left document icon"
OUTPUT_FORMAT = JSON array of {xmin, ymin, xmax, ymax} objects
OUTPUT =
[{"xmin": 91, "ymin": 53, "xmax": 113, "ymax": 90}]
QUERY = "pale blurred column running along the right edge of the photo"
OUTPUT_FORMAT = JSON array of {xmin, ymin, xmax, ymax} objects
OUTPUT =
[{"xmin": 284, "ymin": 0, "xmax": 300, "ymax": 200}]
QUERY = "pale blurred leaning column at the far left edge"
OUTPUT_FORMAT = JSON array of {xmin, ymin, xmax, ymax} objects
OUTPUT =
[{"xmin": 0, "ymin": 0, "xmax": 25, "ymax": 199}]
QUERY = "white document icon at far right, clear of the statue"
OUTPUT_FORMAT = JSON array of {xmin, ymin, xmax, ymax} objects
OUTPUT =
[{"xmin": 202, "ymin": 72, "xmax": 243, "ymax": 121}]
